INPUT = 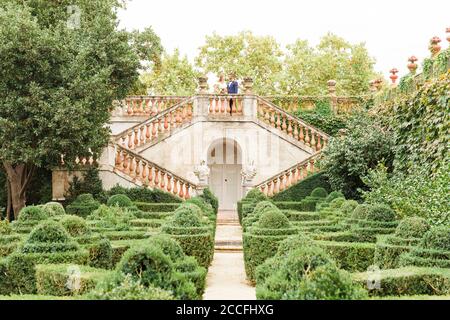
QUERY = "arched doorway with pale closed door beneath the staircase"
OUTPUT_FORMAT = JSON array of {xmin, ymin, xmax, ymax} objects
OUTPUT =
[{"xmin": 208, "ymin": 138, "xmax": 242, "ymax": 210}]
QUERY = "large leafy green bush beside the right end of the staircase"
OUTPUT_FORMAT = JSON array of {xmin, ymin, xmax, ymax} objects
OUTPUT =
[{"xmin": 319, "ymin": 114, "xmax": 394, "ymax": 199}]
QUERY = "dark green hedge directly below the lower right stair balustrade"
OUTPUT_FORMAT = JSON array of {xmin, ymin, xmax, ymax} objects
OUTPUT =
[{"xmin": 272, "ymin": 173, "xmax": 331, "ymax": 201}]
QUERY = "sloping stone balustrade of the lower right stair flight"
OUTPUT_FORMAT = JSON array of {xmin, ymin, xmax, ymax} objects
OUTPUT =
[{"xmin": 255, "ymin": 152, "xmax": 320, "ymax": 197}]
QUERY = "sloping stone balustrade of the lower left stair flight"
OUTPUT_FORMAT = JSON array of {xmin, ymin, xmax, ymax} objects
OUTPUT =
[{"xmin": 114, "ymin": 144, "xmax": 198, "ymax": 199}]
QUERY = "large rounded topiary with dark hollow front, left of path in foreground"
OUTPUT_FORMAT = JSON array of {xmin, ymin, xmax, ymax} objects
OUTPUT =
[{"xmin": 116, "ymin": 245, "xmax": 173, "ymax": 288}]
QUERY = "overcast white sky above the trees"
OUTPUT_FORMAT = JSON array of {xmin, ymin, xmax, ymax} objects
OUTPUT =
[{"xmin": 119, "ymin": 0, "xmax": 450, "ymax": 76}]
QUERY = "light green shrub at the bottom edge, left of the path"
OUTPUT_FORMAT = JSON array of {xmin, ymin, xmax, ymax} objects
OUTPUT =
[{"xmin": 85, "ymin": 273, "xmax": 174, "ymax": 300}]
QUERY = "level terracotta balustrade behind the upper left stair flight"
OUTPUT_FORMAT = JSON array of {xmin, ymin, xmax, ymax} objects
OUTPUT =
[{"xmin": 112, "ymin": 96, "xmax": 189, "ymax": 117}]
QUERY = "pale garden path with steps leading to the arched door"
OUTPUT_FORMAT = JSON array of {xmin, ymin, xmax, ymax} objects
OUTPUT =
[{"xmin": 203, "ymin": 211, "xmax": 256, "ymax": 300}]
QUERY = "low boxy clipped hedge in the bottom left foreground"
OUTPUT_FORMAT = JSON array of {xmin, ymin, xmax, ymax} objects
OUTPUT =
[{"xmin": 36, "ymin": 264, "xmax": 108, "ymax": 296}]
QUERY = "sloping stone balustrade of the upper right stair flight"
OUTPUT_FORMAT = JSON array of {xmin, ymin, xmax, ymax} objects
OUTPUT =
[{"xmin": 257, "ymin": 97, "xmax": 330, "ymax": 151}]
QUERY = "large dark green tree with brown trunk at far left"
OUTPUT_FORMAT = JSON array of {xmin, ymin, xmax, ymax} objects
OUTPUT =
[{"xmin": 0, "ymin": 0, "xmax": 139, "ymax": 218}]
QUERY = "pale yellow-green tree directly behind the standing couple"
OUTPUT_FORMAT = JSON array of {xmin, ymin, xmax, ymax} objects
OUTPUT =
[{"xmin": 196, "ymin": 31, "xmax": 283, "ymax": 95}]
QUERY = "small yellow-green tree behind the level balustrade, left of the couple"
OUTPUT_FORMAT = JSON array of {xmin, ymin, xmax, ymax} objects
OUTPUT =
[{"xmin": 141, "ymin": 49, "xmax": 200, "ymax": 96}]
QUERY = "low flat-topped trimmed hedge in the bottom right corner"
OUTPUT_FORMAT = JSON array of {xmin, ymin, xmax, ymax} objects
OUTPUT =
[{"xmin": 353, "ymin": 267, "xmax": 450, "ymax": 296}]
